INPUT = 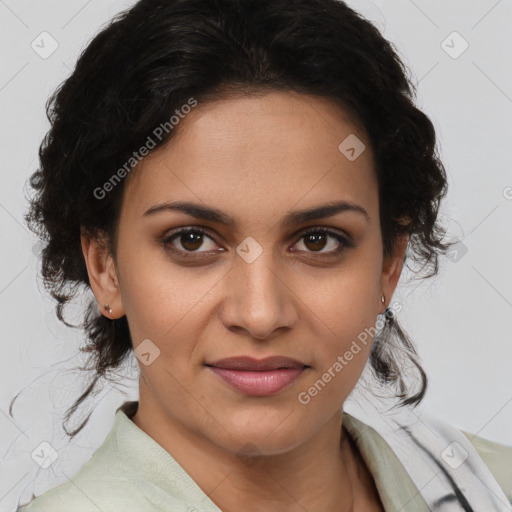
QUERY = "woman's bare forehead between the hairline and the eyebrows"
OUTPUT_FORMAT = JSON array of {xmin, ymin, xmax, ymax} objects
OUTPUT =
[{"xmin": 119, "ymin": 92, "xmax": 378, "ymax": 226}]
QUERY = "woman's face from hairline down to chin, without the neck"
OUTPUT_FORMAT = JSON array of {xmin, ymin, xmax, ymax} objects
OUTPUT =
[{"xmin": 84, "ymin": 92, "xmax": 403, "ymax": 454}]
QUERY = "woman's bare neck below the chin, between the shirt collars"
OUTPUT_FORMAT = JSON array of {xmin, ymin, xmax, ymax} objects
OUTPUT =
[{"xmin": 132, "ymin": 402, "xmax": 361, "ymax": 512}]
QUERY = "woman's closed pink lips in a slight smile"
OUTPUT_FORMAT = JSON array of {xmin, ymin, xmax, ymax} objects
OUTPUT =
[{"xmin": 206, "ymin": 356, "xmax": 308, "ymax": 396}]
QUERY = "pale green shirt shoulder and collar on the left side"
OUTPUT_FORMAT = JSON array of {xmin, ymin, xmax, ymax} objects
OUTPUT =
[{"xmin": 16, "ymin": 402, "xmax": 209, "ymax": 512}]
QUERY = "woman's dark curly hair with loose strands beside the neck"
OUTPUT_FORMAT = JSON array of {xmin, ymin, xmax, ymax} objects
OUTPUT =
[{"xmin": 18, "ymin": 0, "xmax": 450, "ymax": 437}]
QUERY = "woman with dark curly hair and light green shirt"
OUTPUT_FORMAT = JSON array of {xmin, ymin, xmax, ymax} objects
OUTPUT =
[{"xmin": 14, "ymin": 0, "xmax": 512, "ymax": 512}]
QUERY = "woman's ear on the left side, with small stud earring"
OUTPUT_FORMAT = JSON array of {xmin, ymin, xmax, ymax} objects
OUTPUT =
[{"xmin": 80, "ymin": 231, "xmax": 125, "ymax": 319}]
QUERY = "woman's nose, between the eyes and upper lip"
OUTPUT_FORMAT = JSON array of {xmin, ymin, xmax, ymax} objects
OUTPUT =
[{"xmin": 219, "ymin": 252, "xmax": 299, "ymax": 340}]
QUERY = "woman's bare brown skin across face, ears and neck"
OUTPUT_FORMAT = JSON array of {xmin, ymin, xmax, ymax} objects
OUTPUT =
[{"xmin": 82, "ymin": 92, "xmax": 408, "ymax": 512}]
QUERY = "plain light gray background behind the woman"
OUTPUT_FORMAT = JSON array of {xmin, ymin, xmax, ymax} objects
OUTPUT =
[{"xmin": 0, "ymin": 0, "xmax": 512, "ymax": 512}]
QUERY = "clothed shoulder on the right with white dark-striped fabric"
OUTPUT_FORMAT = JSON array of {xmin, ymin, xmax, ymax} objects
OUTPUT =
[{"xmin": 342, "ymin": 406, "xmax": 512, "ymax": 511}]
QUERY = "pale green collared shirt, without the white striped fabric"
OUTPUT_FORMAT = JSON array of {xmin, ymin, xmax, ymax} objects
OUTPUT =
[{"xmin": 18, "ymin": 402, "xmax": 512, "ymax": 512}]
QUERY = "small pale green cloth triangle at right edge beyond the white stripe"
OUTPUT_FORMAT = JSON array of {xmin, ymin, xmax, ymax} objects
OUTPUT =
[{"xmin": 461, "ymin": 430, "xmax": 512, "ymax": 503}]
